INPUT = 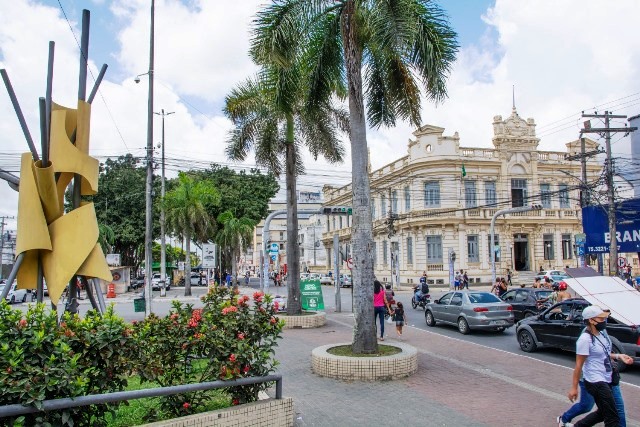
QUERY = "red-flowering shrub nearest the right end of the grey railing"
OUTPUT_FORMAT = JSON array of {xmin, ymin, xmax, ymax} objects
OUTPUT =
[{"xmin": 133, "ymin": 287, "xmax": 282, "ymax": 415}]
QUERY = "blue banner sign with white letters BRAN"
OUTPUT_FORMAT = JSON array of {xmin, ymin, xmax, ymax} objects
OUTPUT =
[{"xmin": 582, "ymin": 199, "xmax": 640, "ymax": 254}]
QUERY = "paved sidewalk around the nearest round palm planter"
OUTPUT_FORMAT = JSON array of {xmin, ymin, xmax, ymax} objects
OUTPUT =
[{"xmin": 269, "ymin": 312, "xmax": 640, "ymax": 427}]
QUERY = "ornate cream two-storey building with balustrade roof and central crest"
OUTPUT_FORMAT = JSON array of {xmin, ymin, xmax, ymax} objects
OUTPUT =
[{"xmin": 323, "ymin": 107, "xmax": 601, "ymax": 283}]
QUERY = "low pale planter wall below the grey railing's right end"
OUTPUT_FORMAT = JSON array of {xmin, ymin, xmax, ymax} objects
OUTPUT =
[{"xmin": 145, "ymin": 397, "xmax": 293, "ymax": 427}]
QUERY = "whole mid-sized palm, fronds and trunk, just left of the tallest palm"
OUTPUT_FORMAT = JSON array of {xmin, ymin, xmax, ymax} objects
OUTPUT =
[{"xmin": 225, "ymin": 64, "xmax": 346, "ymax": 315}]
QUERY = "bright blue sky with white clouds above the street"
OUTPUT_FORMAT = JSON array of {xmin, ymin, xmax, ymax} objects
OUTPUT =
[{"xmin": 0, "ymin": 0, "xmax": 640, "ymax": 232}]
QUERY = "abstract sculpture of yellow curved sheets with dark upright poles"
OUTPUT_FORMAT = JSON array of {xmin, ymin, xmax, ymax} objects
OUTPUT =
[{"xmin": 0, "ymin": 10, "xmax": 112, "ymax": 313}]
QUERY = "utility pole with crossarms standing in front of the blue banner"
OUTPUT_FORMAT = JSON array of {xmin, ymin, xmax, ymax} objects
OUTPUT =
[{"xmin": 580, "ymin": 111, "xmax": 638, "ymax": 276}]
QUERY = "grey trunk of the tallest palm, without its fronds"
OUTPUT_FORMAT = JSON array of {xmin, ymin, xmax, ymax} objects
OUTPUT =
[{"xmin": 336, "ymin": 0, "xmax": 378, "ymax": 353}]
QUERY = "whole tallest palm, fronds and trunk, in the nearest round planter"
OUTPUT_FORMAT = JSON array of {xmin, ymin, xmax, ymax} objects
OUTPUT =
[{"xmin": 252, "ymin": 0, "xmax": 458, "ymax": 353}]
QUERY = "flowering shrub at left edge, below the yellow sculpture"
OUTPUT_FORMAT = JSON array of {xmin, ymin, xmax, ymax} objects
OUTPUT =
[{"xmin": 0, "ymin": 301, "xmax": 136, "ymax": 426}]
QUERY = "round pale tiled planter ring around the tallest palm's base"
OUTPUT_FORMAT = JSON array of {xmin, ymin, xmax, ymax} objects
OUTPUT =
[{"xmin": 311, "ymin": 342, "xmax": 418, "ymax": 381}]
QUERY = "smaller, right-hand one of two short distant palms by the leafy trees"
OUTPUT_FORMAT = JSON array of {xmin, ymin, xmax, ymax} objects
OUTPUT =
[{"xmin": 215, "ymin": 211, "xmax": 256, "ymax": 285}]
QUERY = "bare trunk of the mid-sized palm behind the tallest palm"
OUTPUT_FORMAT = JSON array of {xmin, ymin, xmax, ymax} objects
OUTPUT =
[{"xmin": 286, "ymin": 114, "xmax": 302, "ymax": 315}]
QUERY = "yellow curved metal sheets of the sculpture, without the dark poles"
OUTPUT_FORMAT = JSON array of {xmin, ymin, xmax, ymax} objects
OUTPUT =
[{"xmin": 16, "ymin": 101, "xmax": 112, "ymax": 304}]
